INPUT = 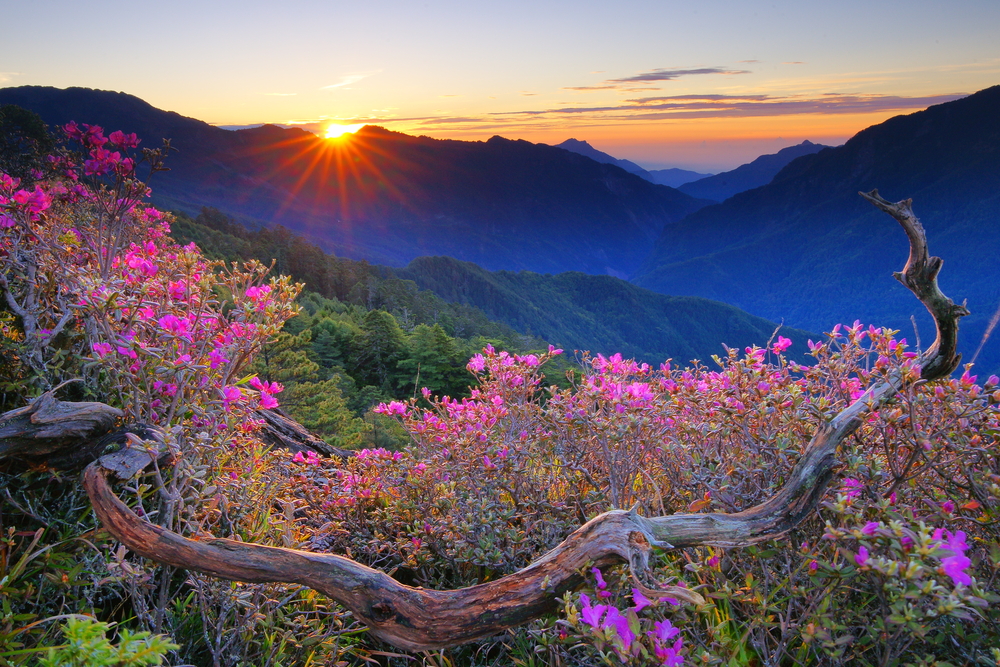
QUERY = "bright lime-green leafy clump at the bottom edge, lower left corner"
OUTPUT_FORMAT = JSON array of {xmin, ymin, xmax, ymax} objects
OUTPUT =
[{"xmin": 38, "ymin": 617, "xmax": 180, "ymax": 667}]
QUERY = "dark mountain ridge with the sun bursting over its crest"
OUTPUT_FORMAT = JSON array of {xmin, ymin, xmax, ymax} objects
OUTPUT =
[{"xmin": 0, "ymin": 86, "xmax": 707, "ymax": 276}]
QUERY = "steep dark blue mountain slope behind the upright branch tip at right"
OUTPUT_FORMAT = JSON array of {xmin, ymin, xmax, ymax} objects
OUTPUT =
[{"xmin": 635, "ymin": 86, "xmax": 1000, "ymax": 371}]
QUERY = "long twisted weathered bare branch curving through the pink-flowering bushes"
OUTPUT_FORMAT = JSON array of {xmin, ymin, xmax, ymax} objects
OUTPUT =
[{"xmin": 84, "ymin": 190, "xmax": 968, "ymax": 650}]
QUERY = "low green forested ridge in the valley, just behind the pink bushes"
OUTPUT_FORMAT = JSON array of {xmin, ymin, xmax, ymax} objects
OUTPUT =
[{"xmin": 393, "ymin": 257, "xmax": 817, "ymax": 363}]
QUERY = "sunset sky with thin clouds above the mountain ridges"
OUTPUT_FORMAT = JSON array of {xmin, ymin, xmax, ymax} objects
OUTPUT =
[{"xmin": 0, "ymin": 0, "xmax": 1000, "ymax": 172}]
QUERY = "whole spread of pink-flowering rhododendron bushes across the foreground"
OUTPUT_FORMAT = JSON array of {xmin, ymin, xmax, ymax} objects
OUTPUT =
[{"xmin": 0, "ymin": 125, "xmax": 1000, "ymax": 665}]
